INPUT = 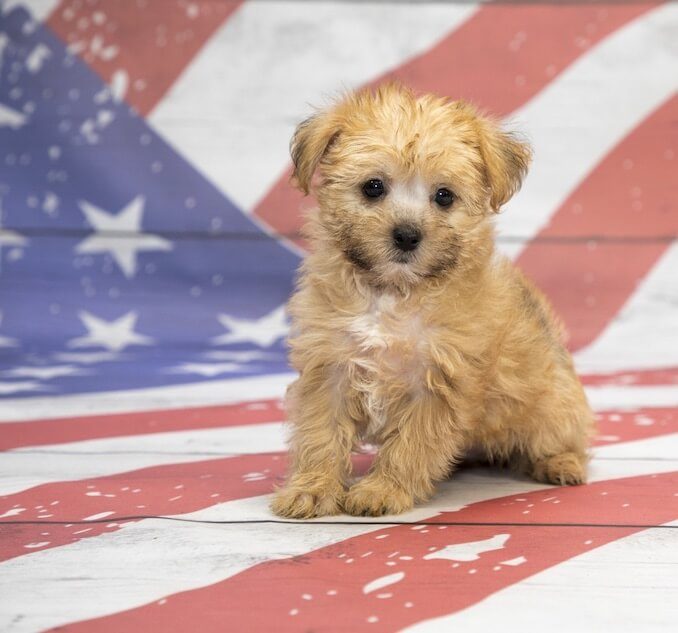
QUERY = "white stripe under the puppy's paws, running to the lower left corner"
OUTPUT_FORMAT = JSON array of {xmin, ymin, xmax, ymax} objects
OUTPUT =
[{"xmin": 0, "ymin": 444, "xmax": 677, "ymax": 633}]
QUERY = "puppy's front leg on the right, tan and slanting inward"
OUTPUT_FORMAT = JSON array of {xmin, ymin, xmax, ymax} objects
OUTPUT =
[{"xmin": 344, "ymin": 394, "xmax": 463, "ymax": 516}]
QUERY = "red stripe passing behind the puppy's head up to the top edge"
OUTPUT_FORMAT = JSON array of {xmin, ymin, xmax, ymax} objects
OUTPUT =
[{"xmin": 254, "ymin": 3, "xmax": 657, "ymax": 247}]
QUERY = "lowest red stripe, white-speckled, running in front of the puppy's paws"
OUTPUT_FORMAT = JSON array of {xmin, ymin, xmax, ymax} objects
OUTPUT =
[{"xmin": 53, "ymin": 473, "xmax": 678, "ymax": 632}]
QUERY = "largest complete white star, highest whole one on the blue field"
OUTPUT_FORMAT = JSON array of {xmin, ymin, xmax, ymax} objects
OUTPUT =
[{"xmin": 75, "ymin": 196, "xmax": 172, "ymax": 277}]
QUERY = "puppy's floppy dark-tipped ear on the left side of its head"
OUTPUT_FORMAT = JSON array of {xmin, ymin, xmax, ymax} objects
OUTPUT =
[{"xmin": 290, "ymin": 112, "xmax": 340, "ymax": 194}]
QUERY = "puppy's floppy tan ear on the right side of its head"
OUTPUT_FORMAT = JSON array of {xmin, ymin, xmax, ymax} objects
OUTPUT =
[{"xmin": 478, "ymin": 119, "xmax": 532, "ymax": 212}]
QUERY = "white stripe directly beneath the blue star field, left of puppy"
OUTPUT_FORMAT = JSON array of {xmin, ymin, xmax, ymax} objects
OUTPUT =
[{"xmin": 0, "ymin": 373, "xmax": 295, "ymax": 423}]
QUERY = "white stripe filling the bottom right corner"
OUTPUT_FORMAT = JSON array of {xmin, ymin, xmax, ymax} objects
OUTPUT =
[{"xmin": 404, "ymin": 523, "xmax": 678, "ymax": 633}]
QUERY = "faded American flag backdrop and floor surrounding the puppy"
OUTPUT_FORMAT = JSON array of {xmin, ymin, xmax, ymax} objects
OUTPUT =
[{"xmin": 0, "ymin": 0, "xmax": 678, "ymax": 633}]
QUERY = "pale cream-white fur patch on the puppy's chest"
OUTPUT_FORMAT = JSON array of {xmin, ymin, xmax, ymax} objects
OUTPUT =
[{"xmin": 348, "ymin": 294, "xmax": 428, "ymax": 436}]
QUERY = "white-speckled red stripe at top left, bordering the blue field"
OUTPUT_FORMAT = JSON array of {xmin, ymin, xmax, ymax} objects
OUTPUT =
[{"xmin": 47, "ymin": 0, "xmax": 241, "ymax": 114}]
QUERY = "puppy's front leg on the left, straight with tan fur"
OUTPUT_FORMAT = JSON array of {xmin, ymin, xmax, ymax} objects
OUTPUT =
[{"xmin": 271, "ymin": 367, "xmax": 355, "ymax": 519}]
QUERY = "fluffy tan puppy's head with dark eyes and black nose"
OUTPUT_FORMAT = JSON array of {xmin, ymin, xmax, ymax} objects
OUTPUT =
[{"xmin": 291, "ymin": 84, "xmax": 530, "ymax": 286}]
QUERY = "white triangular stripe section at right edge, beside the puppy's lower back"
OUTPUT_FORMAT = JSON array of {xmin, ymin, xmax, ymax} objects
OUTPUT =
[{"xmin": 575, "ymin": 239, "xmax": 678, "ymax": 372}]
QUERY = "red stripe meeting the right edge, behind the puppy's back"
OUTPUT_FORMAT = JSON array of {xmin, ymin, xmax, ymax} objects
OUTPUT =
[{"xmin": 517, "ymin": 97, "xmax": 678, "ymax": 350}]
